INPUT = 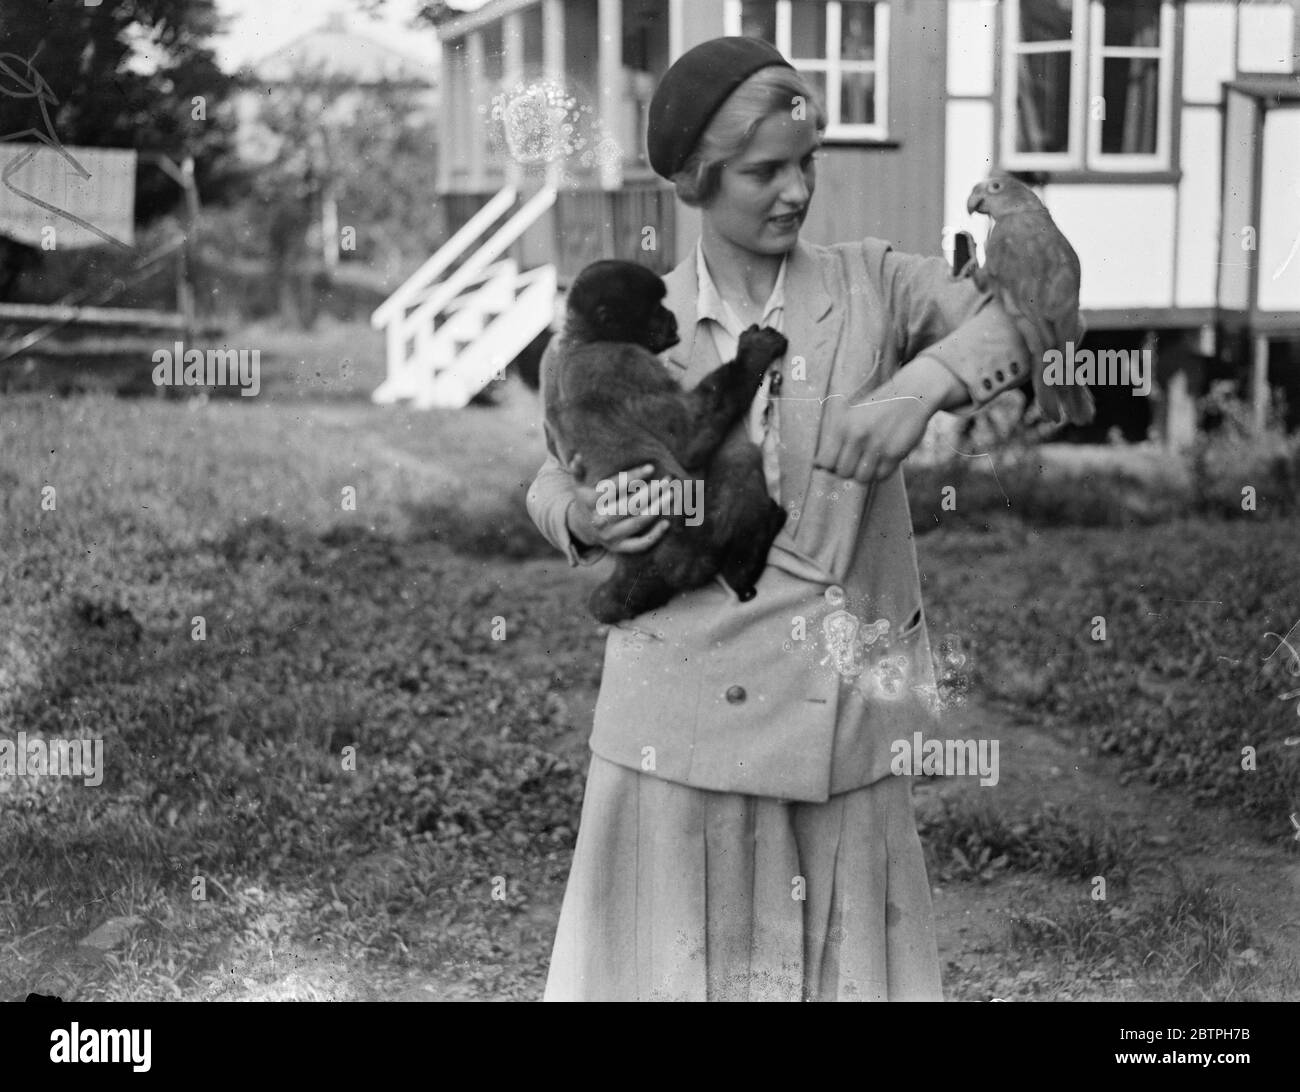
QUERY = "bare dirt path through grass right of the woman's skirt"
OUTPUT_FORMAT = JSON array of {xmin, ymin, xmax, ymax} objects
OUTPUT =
[{"xmin": 917, "ymin": 701, "xmax": 1300, "ymax": 1000}]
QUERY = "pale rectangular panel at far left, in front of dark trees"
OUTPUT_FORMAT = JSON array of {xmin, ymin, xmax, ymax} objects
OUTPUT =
[{"xmin": 0, "ymin": 142, "xmax": 135, "ymax": 250}]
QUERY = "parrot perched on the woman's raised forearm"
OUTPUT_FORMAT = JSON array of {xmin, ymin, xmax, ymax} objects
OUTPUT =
[{"xmin": 961, "ymin": 174, "xmax": 1096, "ymax": 425}]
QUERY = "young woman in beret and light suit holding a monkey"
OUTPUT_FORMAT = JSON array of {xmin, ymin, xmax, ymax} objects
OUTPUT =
[{"xmin": 528, "ymin": 38, "xmax": 1045, "ymax": 1000}]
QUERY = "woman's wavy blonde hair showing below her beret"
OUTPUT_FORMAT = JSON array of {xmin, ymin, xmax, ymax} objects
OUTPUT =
[{"xmin": 672, "ymin": 65, "xmax": 827, "ymax": 208}]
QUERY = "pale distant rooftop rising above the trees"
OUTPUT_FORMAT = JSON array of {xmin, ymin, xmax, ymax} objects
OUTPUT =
[{"xmin": 248, "ymin": 14, "xmax": 437, "ymax": 86}]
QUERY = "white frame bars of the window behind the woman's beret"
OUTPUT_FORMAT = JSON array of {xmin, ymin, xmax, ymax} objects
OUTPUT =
[{"xmin": 723, "ymin": 0, "xmax": 891, "ymax": 143}]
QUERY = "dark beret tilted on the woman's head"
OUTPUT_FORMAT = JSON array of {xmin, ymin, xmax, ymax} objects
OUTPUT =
[{"xmin": 646, "ymin": 38, "xmax": 794, "ymax": 178}]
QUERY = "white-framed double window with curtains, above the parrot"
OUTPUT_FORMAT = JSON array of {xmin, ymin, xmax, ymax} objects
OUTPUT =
[{"xmin": 1001, "ymin": 0, "xmax": 1174, "ymax": 172}]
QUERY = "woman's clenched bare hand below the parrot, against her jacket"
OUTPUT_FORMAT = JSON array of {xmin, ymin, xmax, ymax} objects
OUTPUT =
[{"xmin": 813, "ymin": 356, "xmax": 965, "ymax": 485}]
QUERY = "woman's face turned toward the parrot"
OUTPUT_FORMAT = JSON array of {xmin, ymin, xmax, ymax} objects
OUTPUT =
[{"xmin": 703, "ymin": 113, "xmax": 822, "ymax": 255}]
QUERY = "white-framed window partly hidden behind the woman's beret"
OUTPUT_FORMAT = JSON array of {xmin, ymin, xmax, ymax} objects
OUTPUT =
[{"xmin": 724, "ymin": 0, "xmax": 889, "ymax": 140}]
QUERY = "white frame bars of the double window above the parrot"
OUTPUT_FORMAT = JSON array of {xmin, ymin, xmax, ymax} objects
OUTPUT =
[{"xmin": 998, "ymin": 0, "xmax": 1178, "ymax": 176}]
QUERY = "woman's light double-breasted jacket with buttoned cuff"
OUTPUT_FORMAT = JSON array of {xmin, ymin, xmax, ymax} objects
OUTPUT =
[{"xmin": 528, "ymin": 239, "xmax": 1028, "ymax": 801}]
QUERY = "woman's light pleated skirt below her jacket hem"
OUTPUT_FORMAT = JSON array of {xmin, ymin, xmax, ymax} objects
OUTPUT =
[{"xmin": 545, "ymin": 755, "xmax": 943, "ymax": 1001}]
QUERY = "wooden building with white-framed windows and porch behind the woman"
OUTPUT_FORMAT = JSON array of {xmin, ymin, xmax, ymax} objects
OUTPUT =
[{"xmin": 371, "ymin": 0, "xmax": 1300, "ymax": 423}]
